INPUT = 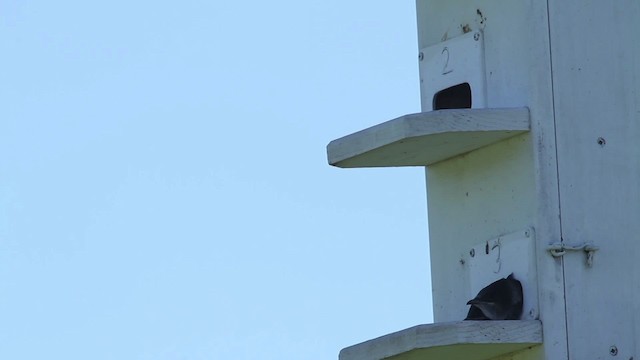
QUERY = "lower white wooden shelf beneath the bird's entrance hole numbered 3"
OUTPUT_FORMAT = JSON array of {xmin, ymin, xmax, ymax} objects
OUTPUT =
[{"xmin": 339, "ymin": 320, "xmax": 542, "ymax": 360}]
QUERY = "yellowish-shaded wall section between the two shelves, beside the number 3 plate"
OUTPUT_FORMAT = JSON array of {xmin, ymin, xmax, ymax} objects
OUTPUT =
[{"xmin": 426, "ymin": 134, "xmax": 537, "ymax": 322}]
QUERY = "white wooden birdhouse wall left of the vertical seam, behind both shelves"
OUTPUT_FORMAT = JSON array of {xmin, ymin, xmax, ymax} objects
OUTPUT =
[{"xmin": 416, "ymin": 0, "xmax": 564, "ymax": 360}]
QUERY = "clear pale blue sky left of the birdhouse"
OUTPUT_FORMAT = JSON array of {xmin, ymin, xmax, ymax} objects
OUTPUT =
[{"xmin": 0, "ymin": 0, "xmax": 432, "ymax": 360}]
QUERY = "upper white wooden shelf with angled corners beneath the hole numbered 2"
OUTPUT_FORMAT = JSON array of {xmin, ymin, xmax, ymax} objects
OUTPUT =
[{"xmin": 327, "ymin": 108, "xmax": 530, "ymax": 168}]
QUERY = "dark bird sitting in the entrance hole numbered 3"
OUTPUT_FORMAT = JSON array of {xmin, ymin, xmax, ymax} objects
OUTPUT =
[{"xmin": 465, "ymin": 274, "xmax": 522, "ymax": 320}]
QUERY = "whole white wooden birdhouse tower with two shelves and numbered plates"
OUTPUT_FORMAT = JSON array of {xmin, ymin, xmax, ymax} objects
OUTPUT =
[{"xmin": 327, "ymin": 0, "xmax": 640, "ymax": 360}]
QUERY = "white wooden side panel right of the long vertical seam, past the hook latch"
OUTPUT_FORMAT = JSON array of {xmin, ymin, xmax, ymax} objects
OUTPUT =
[{"xmin": 545, "ymin": 0, "xmax": 640, "ymax": 360}]
